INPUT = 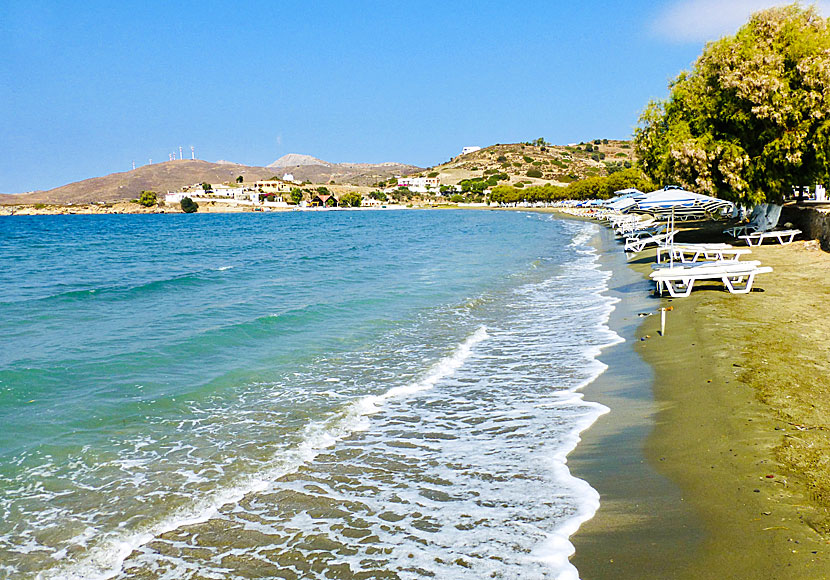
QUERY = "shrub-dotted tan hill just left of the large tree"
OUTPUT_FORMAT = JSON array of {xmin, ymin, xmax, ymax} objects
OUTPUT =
[{"xmin": 418, "ymin": 139, "xmax": 634, "ymax": 185}]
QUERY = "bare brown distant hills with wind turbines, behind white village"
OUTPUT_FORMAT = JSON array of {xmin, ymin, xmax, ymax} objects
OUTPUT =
[{"xmin": 0, "ymin": 156, "xmax": 421, "ymax": 205}]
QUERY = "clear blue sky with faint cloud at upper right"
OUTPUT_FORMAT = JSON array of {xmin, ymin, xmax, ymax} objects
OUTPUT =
[{"xmin": 0, "ymin": 0, "xmax": 830, "ymax": 193}]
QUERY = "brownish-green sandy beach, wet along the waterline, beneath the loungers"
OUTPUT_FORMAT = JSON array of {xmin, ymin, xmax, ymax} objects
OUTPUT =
[{"xmin": 568, "ymin": 221, "xmax": 830, "ymax": 580}]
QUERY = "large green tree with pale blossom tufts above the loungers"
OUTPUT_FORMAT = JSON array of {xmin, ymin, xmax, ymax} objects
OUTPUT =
[{"xmin": 635, "ymin": 4, "xmax": 830, "ymax": 205}]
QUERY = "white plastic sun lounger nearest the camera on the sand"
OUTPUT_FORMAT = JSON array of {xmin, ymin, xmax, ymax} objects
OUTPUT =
[{"xmin": 649, "ymin": 260, "xmax": 772, "ymax": 298}]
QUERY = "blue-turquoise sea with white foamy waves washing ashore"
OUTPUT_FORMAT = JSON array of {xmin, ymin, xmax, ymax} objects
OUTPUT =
[{"xmin": 0, "ymin": 210, "xmax": 621, "ymax": 580}]
